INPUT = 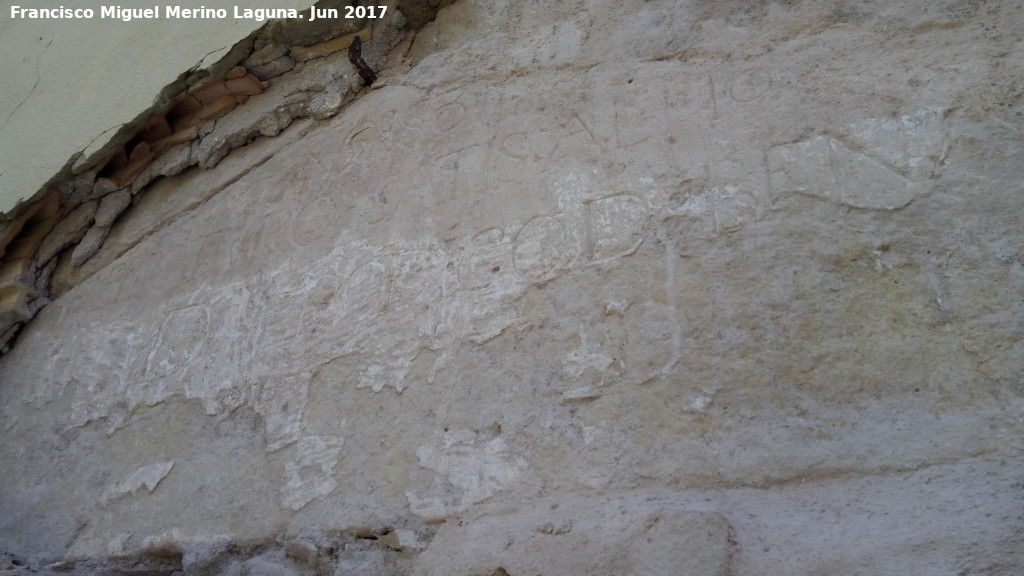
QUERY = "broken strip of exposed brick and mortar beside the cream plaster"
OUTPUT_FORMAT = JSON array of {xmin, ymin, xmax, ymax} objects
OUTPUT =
[{"xmin": 0, "ymin": 0, "xmax": 419, "ymax": 355}]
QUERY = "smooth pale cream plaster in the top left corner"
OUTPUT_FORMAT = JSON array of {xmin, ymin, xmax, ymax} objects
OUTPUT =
[{"xmin": 0, "ymin": 0, "xmax": 310, "ymax": 213}]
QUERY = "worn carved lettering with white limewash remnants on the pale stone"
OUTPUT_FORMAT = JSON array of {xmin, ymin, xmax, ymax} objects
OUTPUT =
[{"xmin": 6, "ymin": 56, "xmax": 948, "ymax": 506}]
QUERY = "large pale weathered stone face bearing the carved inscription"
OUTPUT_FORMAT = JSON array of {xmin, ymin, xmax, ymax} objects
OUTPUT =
[{"xmin": 0, "ymin": 0, "xmax": 1024, "ymax": 576}]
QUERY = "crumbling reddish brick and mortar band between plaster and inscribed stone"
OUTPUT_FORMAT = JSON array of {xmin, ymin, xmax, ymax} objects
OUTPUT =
[{"xmin": 0, "ymin": 0, "xmax": 412, "ymax": 342}]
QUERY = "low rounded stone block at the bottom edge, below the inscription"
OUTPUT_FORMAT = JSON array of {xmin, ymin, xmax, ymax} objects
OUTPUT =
[{"xmin": 414, "ymin": 495, "xmax": 735, "ymax": 576}]
